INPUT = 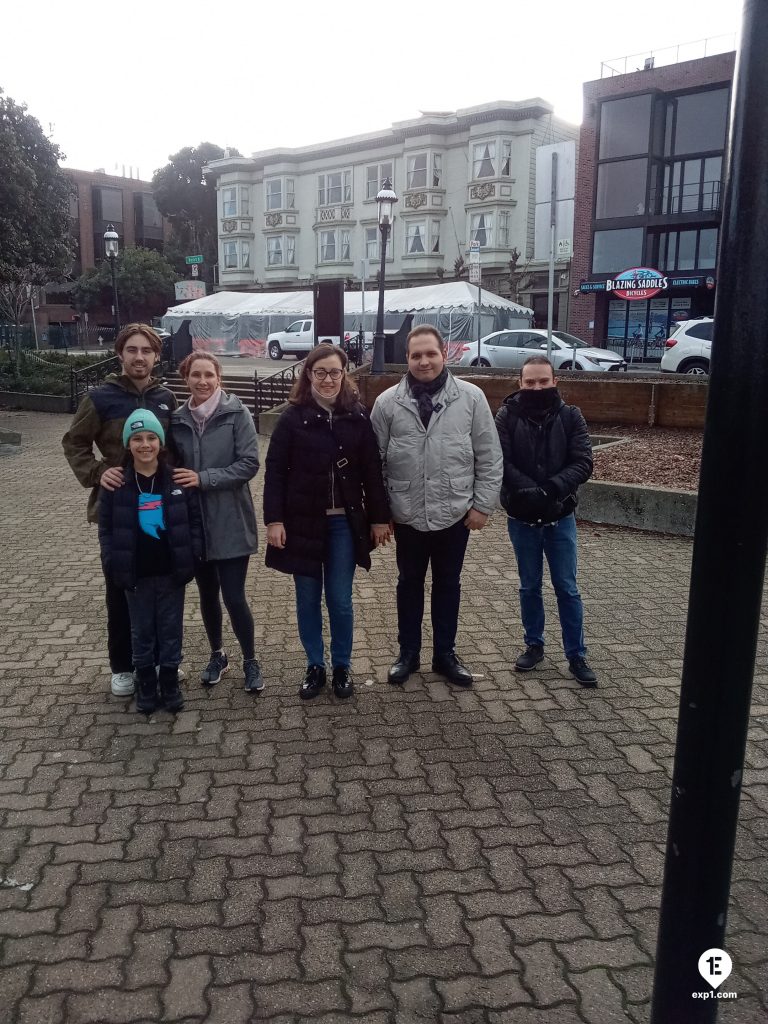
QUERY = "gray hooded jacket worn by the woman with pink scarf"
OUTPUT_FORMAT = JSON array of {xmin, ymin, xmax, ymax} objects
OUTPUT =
[{"xmin": 171, "ymin": 392, "xmax": 259, "ymax": 561}]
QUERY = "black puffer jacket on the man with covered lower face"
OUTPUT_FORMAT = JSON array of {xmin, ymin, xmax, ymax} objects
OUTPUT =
[{"xmin": 496, "ymin": 391, "xmax": 592, "ymax": 523}]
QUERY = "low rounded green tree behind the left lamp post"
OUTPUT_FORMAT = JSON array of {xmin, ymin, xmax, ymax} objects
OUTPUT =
[{"xmin": 72, "ymin": 247, "xmax": 178, "ymax": 324}]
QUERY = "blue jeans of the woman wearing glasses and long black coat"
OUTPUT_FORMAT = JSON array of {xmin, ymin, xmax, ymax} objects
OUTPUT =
[{"xmin": 293, "ymin": 515, "xmax": 355, "ymax": 669}]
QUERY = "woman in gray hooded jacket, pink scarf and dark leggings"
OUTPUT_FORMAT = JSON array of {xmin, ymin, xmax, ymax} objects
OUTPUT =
[{"xmin": 171, "ymin": 352, "xmax": 264, "ymax": 693}]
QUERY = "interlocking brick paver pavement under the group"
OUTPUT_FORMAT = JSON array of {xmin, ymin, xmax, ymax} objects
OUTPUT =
[{"xmin": 0, "ymin": 413, "xmax": 768, "ymax": 1024}]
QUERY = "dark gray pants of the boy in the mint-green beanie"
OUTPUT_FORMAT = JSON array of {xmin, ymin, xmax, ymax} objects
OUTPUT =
[{"xmin": 125, "ymin": 577, "xmax": 184, "ymax": 669}]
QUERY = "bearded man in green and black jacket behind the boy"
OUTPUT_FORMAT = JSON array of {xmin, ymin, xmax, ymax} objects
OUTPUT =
[{"xmin": 61, "ymin": 324, "xmax": 176, "ymax": 697}]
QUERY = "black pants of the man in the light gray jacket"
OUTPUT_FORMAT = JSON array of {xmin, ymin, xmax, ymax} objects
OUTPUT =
[{"xmin": 394, "ymin": 520, "xmax": 469, "ymax": 654}]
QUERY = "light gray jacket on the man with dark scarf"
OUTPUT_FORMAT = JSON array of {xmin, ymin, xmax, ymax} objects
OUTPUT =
[{"xmin": 371, "ymin": 374, "xmax": 502, "ymax": 531}]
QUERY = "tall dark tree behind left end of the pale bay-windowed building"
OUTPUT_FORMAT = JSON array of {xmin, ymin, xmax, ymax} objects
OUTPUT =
[{"xmin": 152, "ymin": 142, "xmax": 241, "ymax": 283}]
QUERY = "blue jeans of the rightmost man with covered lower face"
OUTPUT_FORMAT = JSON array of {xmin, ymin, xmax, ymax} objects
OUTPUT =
[{"xmin": 507, "ymin": 513, "xmax": 587, "ymax": 659}]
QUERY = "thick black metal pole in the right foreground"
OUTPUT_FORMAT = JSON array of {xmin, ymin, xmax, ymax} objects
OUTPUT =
[{"xmin": 651, "ymin": 0, "xmax": 768, "ymax": 1024}]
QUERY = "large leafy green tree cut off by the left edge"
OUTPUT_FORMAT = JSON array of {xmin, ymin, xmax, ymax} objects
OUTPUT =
[{"xmin": 0, "ymin": 89, "xmax": 73, "ymax": 344}]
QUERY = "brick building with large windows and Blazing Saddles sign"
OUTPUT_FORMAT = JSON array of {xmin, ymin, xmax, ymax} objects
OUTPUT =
[{"xmin": 568, "ymin": 52, "xmax": 735, "ymax": 359}]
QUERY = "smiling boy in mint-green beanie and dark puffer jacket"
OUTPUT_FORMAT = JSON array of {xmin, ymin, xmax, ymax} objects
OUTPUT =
[{"xmin": 98, "ymin": 409, "xmax": 203, "ymax": 714}]
